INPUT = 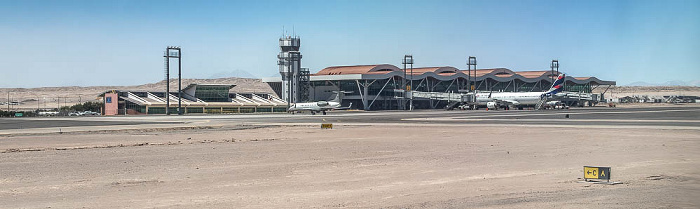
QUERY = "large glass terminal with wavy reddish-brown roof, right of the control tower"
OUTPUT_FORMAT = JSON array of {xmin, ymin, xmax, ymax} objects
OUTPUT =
[{"xmin": 263, "ymin": 64, "xmax": 615, "ymax": 110}]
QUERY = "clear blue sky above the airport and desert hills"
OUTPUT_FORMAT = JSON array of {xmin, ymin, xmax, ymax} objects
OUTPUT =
[{"xmin": 0, "ymin": 0, "xmax": 700, "ymax": 87}]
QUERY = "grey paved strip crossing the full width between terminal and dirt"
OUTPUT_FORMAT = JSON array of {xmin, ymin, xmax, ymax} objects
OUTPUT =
[{"xmin": 0, "ymin": 105, "xmax": 700, "ymax": 130}]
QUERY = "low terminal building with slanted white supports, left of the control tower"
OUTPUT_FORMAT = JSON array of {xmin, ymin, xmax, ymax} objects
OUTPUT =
[{"xmin": 101, "ymin": 84, "xmax": 287, "ymax": 115}]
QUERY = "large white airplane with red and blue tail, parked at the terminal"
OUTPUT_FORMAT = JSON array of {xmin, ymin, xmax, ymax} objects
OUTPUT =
[{"xmin": 476, "ymin": 74, "xmax": 566, "ymax": 109}]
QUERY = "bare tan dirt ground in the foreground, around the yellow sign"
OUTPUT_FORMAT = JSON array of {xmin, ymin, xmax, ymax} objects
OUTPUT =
[{"xmin": 0, "ymin": 124, "xmax": 700, "ymax": 208}]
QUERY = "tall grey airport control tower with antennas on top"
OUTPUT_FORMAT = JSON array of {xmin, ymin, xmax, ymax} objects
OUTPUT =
[{"xmin": 277, "ymin": 36, "xmax": 309, "ymax": 103}]
